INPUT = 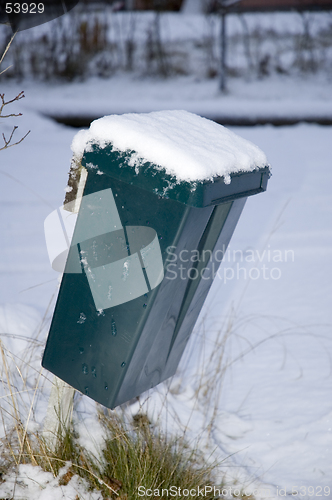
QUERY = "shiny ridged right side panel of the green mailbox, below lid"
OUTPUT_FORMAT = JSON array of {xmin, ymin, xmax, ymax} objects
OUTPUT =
[{"xmin": 115, "ymin": 198, "xmax": 246, "ymax": 406}]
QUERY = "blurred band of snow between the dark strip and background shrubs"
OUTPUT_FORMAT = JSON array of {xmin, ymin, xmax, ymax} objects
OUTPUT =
[{"xmin": 11, "ymin": 74, "xmax": 332, "ymax": 121}]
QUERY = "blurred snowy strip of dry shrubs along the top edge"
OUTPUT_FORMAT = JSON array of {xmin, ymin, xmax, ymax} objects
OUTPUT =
[{"xmin": 0, "ymin": 0, "xmax": 332, "ymax": 86}]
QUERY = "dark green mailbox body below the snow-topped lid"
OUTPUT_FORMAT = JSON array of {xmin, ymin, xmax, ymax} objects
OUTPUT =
[{"xmin": 43, "ymin": 171, "xmax": 244, "ymax": 408}]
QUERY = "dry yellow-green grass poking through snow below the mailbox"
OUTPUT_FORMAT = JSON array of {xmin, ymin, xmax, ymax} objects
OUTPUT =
[{"xmin": 0, "ymin": 316, "xmax": 233, "ymax": 500}]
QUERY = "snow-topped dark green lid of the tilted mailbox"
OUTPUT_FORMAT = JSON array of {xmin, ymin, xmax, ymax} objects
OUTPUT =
[{"xmin": 72, "ymin": 110, "xmax": 270, "ymax": 208}]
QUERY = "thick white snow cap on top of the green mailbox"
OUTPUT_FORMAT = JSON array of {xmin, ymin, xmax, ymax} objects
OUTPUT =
[{"xmin": 72, "ymin": 110, "xmax": 267, "ymax": 183}]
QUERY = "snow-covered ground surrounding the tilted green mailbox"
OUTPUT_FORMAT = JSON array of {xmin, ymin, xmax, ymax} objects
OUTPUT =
[{"xmin": 0, "ymin": 68, "xmax": 332, "ymax": 499}]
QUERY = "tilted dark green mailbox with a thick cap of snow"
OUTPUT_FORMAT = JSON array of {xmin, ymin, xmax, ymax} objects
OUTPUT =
[{"xmin": 42, "ymin": 111, "xmax": 270, "ymax": 408}]
